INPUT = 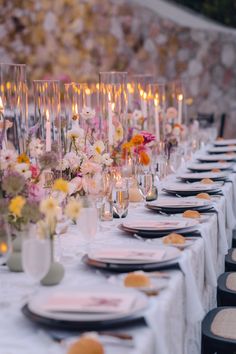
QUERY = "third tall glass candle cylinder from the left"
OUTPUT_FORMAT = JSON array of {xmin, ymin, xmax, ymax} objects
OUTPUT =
[{"xmin": 65, "ymin": 82, "xmax": 99, "ymax": 152}]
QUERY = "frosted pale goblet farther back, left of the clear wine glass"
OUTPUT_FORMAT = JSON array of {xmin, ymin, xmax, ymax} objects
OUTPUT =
[{"xmin": 78, "ymin": 196, "xmax": 98, "ymax": 251}]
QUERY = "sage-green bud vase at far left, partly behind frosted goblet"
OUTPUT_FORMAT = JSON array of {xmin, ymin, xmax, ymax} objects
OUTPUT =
[{"xmin": 7, "ymin": 231, "xmax": 24, "ymax": 272}]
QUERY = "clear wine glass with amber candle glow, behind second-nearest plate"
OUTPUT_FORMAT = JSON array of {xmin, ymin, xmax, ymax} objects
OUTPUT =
[{"xmin": 112, "ymin": 177, "xmax": 129, "ymax": 218}]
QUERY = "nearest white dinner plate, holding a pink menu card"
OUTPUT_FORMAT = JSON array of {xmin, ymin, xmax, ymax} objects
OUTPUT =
[{"xmin": 28, "ymin": 285, "xmax": 148, "ymax": 322}]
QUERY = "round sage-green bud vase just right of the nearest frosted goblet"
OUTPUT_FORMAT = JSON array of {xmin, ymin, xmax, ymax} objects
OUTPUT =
[{"xmin": 41, "ymin": 237, "xmax": 65, "ymax": 286}]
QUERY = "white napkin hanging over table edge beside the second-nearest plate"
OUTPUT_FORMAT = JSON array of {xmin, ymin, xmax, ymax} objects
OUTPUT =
[{"xmin": 179, "ymin": 250, "xmax": 204, "ymax": 323}]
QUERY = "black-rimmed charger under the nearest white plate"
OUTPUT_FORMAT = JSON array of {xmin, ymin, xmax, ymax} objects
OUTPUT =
[{"xmin": 22, "ymin": 286, "xmax": 148, "ymax": 331}]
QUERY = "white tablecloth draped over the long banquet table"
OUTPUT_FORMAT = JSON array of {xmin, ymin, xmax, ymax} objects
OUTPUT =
[{"xmin": 0, "ymin": 147, "xmax": 236, "ymax": 354}]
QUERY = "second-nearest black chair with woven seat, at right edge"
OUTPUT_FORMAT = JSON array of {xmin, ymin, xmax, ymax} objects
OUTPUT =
[{"xmin": 217, "ymin": 272, "xmax": 236, "ymax": 306}]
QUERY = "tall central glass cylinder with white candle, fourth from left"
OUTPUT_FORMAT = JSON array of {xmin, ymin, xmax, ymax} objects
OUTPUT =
[{"xmin": 99, "ymin": 72, "xmax": 128, "ymax": 152}]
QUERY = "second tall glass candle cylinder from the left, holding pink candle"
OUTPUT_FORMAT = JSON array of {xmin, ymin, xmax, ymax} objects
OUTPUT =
[{"xmin": 30, "ymin": 80, "xmax": 61, "ymax": 158}]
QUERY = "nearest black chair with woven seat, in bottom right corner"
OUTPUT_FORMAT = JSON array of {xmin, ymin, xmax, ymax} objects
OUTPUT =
[{"xmin": 201, "ymin": 307, "xmax": 236, "ymax": 354}]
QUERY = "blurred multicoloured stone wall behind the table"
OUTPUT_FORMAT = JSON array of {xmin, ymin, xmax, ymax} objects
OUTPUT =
[{"xmin": 0, "ymin": 0, "xmax": 236, "ymax": 134}]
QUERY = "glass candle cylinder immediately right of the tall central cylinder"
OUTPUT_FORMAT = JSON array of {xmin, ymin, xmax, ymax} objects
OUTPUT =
[{"xmin": 127, "ymin": 74, "xmax": 154, "ymax": 131}]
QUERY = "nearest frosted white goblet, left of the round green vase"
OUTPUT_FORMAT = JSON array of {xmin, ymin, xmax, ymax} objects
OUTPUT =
[{"xmin": 22, "ymin": 224, "xmax": 51, "ymax": 282}]
